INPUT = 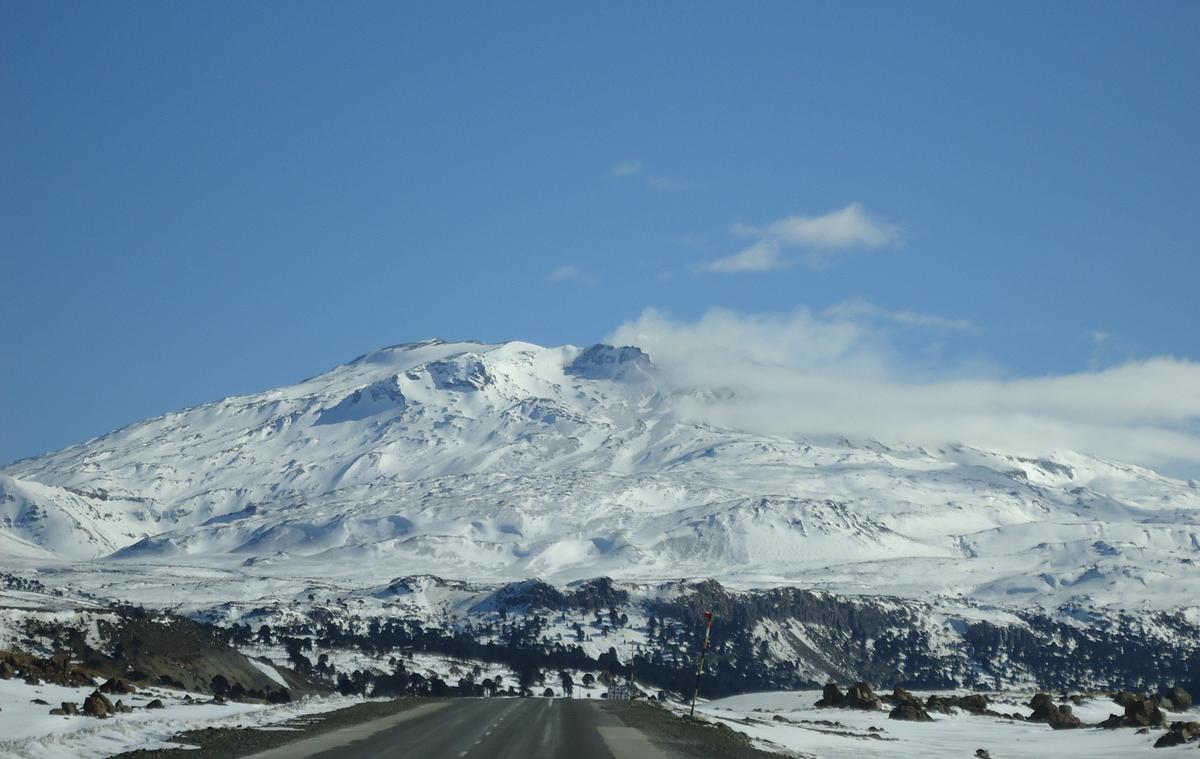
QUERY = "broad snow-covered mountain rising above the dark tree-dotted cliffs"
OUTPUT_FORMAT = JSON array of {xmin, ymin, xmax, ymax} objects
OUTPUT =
[{"xmin": 0, "ymin": 341, "xmax": 1200, "ymax": 608}]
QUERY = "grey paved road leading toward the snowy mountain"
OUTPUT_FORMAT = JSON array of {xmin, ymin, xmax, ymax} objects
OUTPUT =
[{"xmin": 252, "ymin": 699, "xmax": 674, "ymax": 759}]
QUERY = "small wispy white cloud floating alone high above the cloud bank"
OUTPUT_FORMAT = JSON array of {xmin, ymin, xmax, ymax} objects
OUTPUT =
[{"xmin": 700, "ymin": 203, "xmax": 900, "ymax": 274}]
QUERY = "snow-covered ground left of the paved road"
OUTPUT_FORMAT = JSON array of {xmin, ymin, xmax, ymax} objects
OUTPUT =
[{"xmin": 0, "ymin": 680, "xmax": 361, "ymax": 759}]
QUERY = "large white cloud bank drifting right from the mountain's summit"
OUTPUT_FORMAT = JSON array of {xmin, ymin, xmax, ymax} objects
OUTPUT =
[{"xmin": 608, "ymin": 306, "xmax": 1200, "ymax": 476}]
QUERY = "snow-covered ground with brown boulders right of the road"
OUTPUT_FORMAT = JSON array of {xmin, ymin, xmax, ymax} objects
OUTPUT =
[{"xmin": 696, "ymin": 691, "xmax": 1200, "ymax": 759}]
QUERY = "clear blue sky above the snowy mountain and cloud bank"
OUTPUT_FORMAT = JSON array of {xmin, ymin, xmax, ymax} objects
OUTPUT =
[{"xmin": 0, "ymin": 0, "xmax": 1200, "ymax": 472}]
